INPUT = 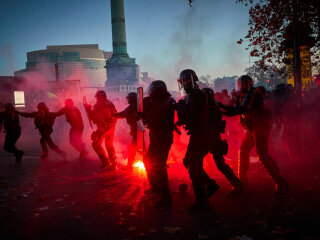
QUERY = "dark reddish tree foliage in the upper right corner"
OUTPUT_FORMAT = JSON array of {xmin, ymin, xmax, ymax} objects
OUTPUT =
[{"xmin": 237, "ymin": 0, "xmax": 320, "ymax": 70}]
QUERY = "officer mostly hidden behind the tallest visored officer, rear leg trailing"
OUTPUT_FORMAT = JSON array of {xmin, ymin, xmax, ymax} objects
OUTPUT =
[{"xmin": 203, "ymin": 88, "xmax": 242, "ymax": 195}]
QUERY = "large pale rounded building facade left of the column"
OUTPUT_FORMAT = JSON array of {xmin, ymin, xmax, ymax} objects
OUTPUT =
[{"xmin": 14, "ymin": 44, "xmax": 112, "ymax": 88}]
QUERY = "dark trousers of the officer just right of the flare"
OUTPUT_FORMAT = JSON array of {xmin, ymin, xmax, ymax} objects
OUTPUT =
[{"xmin": 143, "ymin": 131, "xmax": 173, "ymax": 200}]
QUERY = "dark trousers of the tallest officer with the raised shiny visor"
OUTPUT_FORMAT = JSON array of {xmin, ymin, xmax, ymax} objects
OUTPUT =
[{"xmin": 183, "ymin": 131, "xmax": 215, "ymax": 204}]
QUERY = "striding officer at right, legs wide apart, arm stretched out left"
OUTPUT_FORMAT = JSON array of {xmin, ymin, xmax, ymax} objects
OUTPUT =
[{"xmin": 220, "ymin": 75, "xmax": 288, "ymax": 193}]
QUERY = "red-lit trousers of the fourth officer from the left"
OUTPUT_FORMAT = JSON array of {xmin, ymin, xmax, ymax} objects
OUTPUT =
[{"xmin": 91, "ymin": 128, "xmax": 117, "ymax": 164}]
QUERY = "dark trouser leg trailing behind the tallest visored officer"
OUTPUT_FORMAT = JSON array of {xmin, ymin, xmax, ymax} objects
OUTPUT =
[{"xmin": 210, "ymin": 132, "xmax": 241, "ymax": 188}]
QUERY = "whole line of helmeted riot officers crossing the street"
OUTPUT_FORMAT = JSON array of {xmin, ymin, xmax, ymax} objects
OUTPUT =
[{"xmin": 0, "ymin": 69, "xmax": 320, "ymax": 211}]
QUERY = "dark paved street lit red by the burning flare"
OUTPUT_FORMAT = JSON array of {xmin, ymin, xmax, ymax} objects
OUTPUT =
[{"xmin": 0, "ymin": 152, "xmax": 320, "ymax": 240}]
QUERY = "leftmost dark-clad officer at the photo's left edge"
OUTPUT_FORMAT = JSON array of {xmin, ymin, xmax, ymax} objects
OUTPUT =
[{"xmin": 0, "ymin": 103, "xmax": 24, "ymax": 162}]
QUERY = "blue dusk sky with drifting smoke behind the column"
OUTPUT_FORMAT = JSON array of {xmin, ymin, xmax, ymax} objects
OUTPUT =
[{"xmin": 0, "ymin": 0, "xmax": 252, "ymax": 88}]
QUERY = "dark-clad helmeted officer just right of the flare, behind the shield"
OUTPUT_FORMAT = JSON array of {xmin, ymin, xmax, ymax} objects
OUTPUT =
[{"xmin": 143, "ymin": 80, "xmax": 175, "ymax": 207}]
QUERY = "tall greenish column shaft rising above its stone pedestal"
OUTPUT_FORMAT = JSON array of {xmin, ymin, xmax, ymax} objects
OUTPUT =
[{"xmin": 110, "ymin": 0, "xmax": 128, "ymax": 56}]
